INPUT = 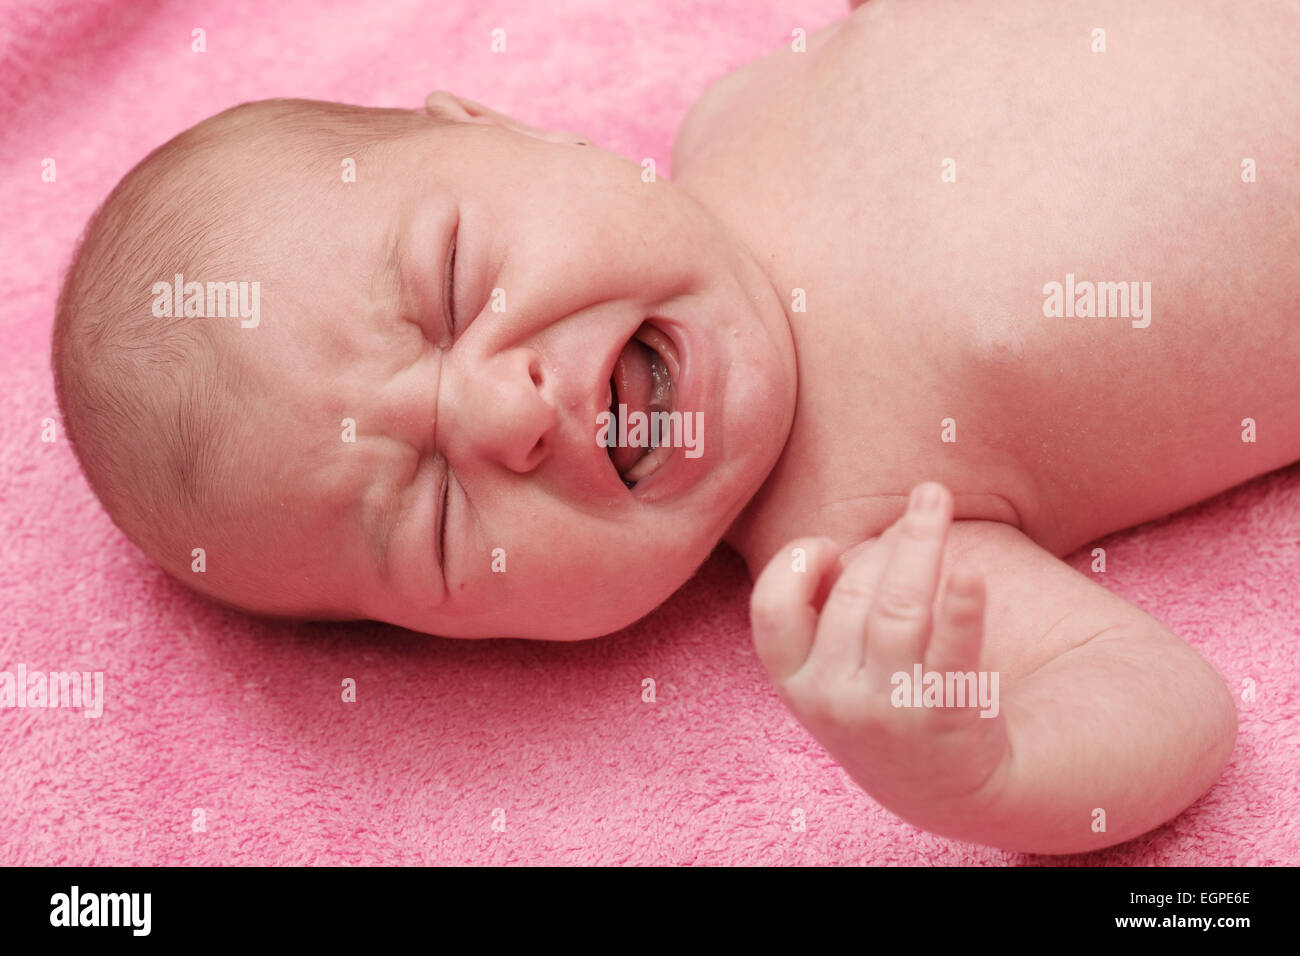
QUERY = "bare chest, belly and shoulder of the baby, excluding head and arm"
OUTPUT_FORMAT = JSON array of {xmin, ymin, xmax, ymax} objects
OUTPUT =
[{"xmin": 673, "ymin": 0, "xmax": 1300, "ymax": 564}]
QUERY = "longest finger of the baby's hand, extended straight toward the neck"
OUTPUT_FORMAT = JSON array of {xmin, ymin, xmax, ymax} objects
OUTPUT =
[{"xmin": 866, "ymin": 481, "xmax": 953, "ymax": 682}]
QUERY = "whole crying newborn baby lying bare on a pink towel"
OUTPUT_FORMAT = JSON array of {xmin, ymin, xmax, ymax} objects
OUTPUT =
[{"xmin": 53, "ymin": 0, "xmax": 1300, "ymax": 853}]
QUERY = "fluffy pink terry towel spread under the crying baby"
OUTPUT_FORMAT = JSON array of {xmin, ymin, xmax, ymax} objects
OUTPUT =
[{"xmin": 0, "ymin": 0, "xmax": 1300, "ymax": 864}]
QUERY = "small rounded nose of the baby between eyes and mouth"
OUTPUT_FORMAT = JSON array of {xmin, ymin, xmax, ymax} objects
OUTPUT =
[{"xmin": 454, "ymin": 349, "xmax": 558, "ymax": 473}]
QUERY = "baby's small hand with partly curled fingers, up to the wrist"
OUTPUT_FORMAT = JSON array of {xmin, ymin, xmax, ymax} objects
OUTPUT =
[{"xmin": 750, "ymin": 483, "xmax": 1010, "ymax": 831}]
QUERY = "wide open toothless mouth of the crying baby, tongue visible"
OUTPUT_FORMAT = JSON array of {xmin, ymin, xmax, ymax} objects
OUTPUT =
[{"xmin": 610, "ymin": 323, "xmax": 680, "ymax": 488}]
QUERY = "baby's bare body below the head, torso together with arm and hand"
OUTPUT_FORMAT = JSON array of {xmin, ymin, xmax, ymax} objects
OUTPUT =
[{"xmin": 673, "ymin": 0, "xmax": 1300, "ymax": 852}]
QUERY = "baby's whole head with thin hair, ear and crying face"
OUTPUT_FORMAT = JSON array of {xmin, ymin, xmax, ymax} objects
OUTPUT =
[{"xmin": 53, "ymin": 94, "xmax": 796, "ymax": 639}]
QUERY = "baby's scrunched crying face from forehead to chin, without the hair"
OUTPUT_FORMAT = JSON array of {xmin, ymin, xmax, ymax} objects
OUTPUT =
[{"xmin": 208, "ymin": 113, "xmax": 796, "ymax": 639}]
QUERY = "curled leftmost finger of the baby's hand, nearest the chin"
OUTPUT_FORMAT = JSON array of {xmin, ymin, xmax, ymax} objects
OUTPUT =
[{"xmin": 749, "ymin": 537, "xmax": 840, "ymax": 683}]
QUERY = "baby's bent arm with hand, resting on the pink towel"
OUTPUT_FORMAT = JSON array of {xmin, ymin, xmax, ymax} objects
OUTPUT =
[{"xmin": 750, "ymin": 484, "xmax": 1236, "ymax": 853}]
